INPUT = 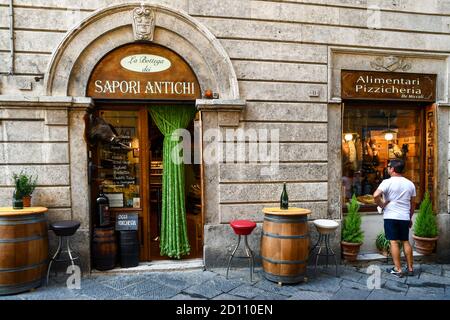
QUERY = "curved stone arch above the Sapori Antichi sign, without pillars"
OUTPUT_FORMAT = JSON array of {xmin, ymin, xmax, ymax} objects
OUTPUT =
[{"xmin": 44, "ymin": 3, "xmax": 239, "ymax": 100}]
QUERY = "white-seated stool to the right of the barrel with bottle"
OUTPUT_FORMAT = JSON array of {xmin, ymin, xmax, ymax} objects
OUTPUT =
[{"xmin": 310, "ymin": 219, "xmax": 339, "ymax": 276}]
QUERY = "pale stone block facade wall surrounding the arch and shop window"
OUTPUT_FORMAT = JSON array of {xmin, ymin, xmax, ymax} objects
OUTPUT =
[{"xmin": 0, "ymin": 0, "xmax": 450, "ymax": 265}]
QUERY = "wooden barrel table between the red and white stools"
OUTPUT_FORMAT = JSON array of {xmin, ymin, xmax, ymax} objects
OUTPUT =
[{"xmin": 261, "ymin": 208, "xmax": 311, "ymax": 285}]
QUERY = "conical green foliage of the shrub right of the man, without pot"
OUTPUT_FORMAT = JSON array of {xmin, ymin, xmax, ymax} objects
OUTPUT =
[{"xmin": 414, "ymin": 192, "xmax": 438, "ymax": 238}]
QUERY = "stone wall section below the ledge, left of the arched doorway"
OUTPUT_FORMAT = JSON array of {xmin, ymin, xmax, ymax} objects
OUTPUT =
[{"xmin": 0, "ymin": 97, "xmax": 90, "ymax": 268}]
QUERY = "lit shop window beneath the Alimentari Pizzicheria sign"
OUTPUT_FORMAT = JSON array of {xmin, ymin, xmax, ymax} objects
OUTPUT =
[{"xmin": 342, "ymin": 103, "xmax": 426, "ymax": 212}]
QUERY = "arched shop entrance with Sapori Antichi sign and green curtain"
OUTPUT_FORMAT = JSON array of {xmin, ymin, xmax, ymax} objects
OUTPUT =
[{"xmin": 86, "ymin": 42, "xmax": 203, "ymax": 261}]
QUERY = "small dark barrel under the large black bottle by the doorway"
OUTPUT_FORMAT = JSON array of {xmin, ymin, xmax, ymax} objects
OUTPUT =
[{"xmin": 92, "ymin": 227, "xmax": 117, "ymax": 270}]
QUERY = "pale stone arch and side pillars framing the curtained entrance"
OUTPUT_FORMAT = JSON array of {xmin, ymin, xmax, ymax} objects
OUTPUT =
[{"xmin": 44, "ymin": 2, "xmax": 245, "ymax": 272}]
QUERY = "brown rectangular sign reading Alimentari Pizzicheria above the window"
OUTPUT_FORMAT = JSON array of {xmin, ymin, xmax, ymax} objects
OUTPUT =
[{"xmin": 341, "ymin": 70, "xmax": 436, "ymax": 102}]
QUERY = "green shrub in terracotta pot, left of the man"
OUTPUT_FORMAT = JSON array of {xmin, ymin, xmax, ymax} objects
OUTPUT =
[{"xmin": 341, "ymin": 194, "xmax": 364, "ymax": 261}]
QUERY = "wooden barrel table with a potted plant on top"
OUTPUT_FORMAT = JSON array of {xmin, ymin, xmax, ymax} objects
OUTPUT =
[{"xmin": 0, "ymin": 207, "xmax": 48, "ymax": 295}]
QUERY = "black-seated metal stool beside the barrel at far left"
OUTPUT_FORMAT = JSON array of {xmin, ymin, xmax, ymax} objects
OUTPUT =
[{"xmin": 47, "ymin": 220, "xmax": 80, "ymax": 285}]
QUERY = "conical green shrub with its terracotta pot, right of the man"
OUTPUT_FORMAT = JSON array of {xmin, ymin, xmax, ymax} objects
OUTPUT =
[{"xmin": 413, "ymin": 192, "xmax": 438, "ymax": 255}]
